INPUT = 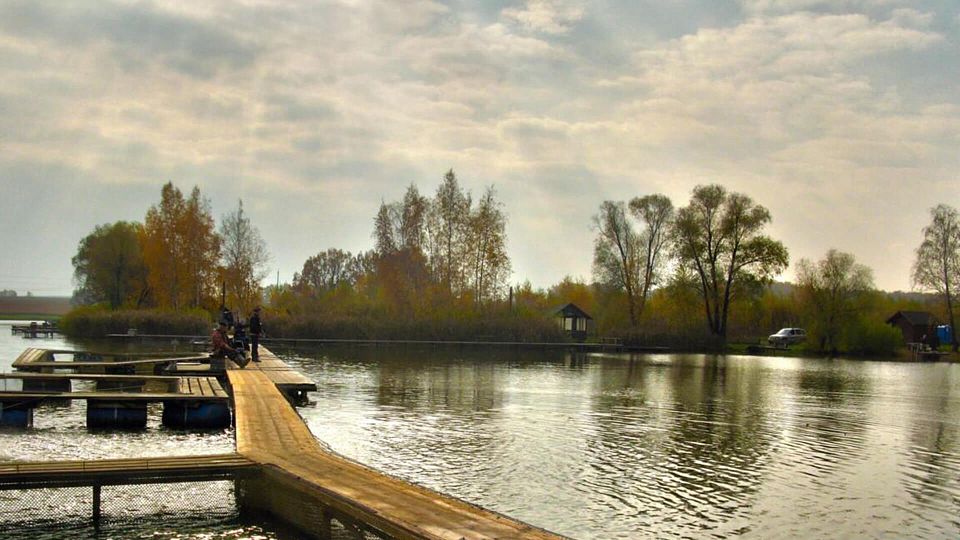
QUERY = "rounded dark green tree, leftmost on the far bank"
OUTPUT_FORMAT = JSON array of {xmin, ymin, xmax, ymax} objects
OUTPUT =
[{"xmin": 72, "ymin": 221, "xmax": 149, "ymax": 309}]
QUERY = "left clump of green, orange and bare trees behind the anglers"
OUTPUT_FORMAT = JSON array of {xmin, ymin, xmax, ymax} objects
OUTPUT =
[{"xmin": 72, "ymin": 183, "xmax": 269, "ymax": 311}]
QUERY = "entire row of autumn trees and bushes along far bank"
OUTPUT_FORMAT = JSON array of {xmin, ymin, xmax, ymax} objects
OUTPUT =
[{"xmin": 63, "ymin": 175, "xmax": 960, "ymax": 354}]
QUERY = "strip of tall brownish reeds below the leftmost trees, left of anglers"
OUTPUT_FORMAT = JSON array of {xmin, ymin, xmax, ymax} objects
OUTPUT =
[{"xmin": 59, "ymin": 306, "xmax": 212, "ymax": 338}]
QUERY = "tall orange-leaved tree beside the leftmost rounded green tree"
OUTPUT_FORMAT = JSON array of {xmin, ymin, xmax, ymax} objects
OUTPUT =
[{"xmin": 142, "ymin": 182, "xmax": 220, "ymax": 309}]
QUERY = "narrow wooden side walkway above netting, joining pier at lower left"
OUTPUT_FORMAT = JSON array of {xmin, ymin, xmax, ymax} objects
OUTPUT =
[{"xmin": 0, "ymin": 454, "xmax": 257, "ymax": 490}]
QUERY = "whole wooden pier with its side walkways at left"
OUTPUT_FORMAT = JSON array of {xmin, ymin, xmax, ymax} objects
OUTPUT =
[{"xmin": 0, "ymin": 346, "xmax": 561, "ymax": 540}]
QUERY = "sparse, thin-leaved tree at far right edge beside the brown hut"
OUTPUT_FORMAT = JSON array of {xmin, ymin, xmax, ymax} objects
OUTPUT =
[{"xmin": 913, "ymin": 204, "xmax": 960, "ymax": 352}]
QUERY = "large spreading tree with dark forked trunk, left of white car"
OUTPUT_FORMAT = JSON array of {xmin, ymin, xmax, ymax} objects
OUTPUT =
[{"xmin": 673, "ymin": 184, "xmax": 789, "ymax": 338}]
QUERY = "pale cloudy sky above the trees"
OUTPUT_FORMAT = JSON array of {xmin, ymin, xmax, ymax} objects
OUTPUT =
[{"xmin": 0, "ymin": 0, "xmax": 960, "ymax": 295}]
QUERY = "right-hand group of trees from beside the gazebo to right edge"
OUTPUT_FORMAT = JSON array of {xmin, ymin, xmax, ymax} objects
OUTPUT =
[{"xmin": 587, "ymin": 184, "xmax": 960, "ymax": 353}]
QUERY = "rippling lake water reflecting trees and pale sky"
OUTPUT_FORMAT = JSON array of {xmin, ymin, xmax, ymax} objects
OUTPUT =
[{"xmin": 0, "ymin": 326, "xmax": 960, "ymax": 539}]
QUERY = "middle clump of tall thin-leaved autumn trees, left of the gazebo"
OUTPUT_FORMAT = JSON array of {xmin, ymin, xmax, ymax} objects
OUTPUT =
[{"xmin": 270, "ymin": 170, "xmax": 524, "ymax": 339}]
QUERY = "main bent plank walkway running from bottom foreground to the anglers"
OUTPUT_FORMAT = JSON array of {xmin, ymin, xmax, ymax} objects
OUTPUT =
[{"xmin": 228, "ymin": 347, "xmax": 558, "ymax": 540}]
